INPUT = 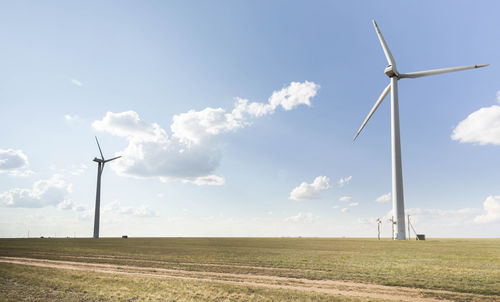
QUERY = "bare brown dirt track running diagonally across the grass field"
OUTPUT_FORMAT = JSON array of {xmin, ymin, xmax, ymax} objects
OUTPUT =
[{"xmin": 0, "ymin": 257, "xmax": 494, "ymax": 301}]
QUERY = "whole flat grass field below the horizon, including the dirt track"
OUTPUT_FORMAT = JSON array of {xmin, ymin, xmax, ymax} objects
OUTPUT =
[{"xmin": 0, "ymin": 238, "xmax": 500, "ymax": 301}]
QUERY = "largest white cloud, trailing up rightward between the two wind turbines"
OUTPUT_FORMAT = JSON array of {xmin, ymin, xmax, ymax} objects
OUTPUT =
[{"xmin": 92, "ymin": 81, "xmax": 319, "ymax": 185}]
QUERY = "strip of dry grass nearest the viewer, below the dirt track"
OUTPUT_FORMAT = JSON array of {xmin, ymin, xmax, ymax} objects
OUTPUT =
[{"xmin": 0, "ymin": 264, "xmax": 373, "ymax": 301}]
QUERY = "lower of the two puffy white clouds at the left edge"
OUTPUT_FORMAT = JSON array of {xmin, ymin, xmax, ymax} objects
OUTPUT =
[{"xmin": 0, "ymin": 174, "xmax": 71, "ymax": 208}]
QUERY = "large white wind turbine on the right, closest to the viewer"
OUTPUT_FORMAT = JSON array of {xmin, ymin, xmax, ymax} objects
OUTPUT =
[{"xmin": 353, "ymin": 20, "xmax": 489, "ymax": 240}]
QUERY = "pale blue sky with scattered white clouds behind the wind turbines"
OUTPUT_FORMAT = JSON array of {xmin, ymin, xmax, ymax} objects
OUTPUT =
[{"xmin": 0, "ymin": 1, "xmax": 500, "ymax": 238}]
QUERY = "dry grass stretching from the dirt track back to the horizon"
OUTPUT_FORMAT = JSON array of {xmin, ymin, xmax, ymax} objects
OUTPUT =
[{"xmin": 0, "ymin": 238, "xmax": 500, "ymax": 300}]
